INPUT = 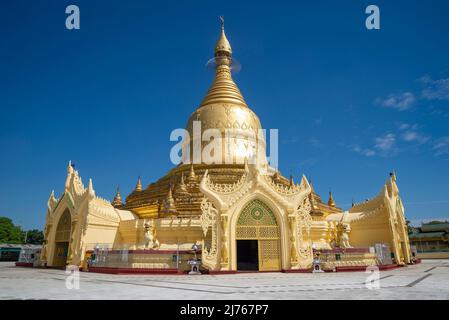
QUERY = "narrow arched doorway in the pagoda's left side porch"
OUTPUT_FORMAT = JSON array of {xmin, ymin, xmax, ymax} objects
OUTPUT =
[{"xmin": 52, "ymin": 210, "xmax": 72, "ymax": 267}]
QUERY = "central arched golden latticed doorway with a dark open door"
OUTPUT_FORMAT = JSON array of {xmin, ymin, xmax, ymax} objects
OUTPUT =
[{"xmin": 236, "ymin": 199, "xmax": 281, "ymax": 271}]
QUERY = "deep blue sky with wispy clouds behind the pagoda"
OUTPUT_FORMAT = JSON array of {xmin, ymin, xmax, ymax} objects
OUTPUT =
[{"xmin": 0, "ymin": 0, "xmax": 449, "ymax": 228}]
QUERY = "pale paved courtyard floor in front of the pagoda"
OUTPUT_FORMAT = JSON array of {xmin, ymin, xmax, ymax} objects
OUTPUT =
[{"xmin": 0, "ymin": 260, "xmax": 449, "ymax": 300}]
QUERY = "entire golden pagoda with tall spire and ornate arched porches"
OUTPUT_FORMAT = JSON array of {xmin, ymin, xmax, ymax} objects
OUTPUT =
[{"xmin": 41, "ymin": 23, "xmax": 411, "ymax": 273}]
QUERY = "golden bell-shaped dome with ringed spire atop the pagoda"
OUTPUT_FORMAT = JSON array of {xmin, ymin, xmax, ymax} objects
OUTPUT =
[{"xmin": 186, "ymin": 20, "xmax": 265, "ymax": 165}]
